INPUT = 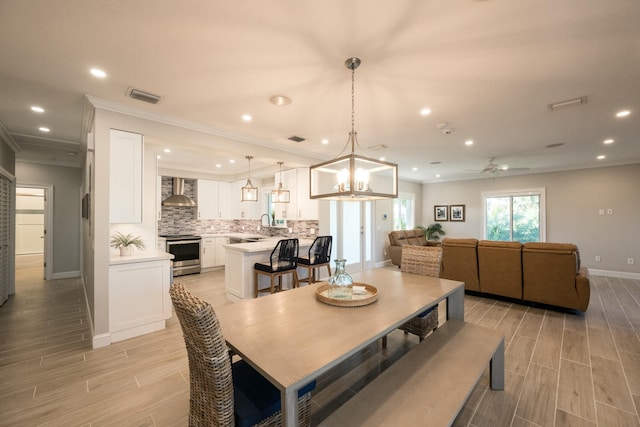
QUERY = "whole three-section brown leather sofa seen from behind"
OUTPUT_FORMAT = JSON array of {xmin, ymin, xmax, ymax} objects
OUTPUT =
[{"xmin": 440, "ymin": 238, "xmax": 590, "ymax": 311}]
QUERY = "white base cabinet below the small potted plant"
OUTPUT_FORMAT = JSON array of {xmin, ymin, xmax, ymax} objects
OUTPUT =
[{"xmin": 109, "ymin": 255, "xmax": 171, "ymax": 342}]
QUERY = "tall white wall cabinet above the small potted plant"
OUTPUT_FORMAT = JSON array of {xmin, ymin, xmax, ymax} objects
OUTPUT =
[{"xmin": 109, "ymin": 129, "xmax": 143, "ymax": 224}]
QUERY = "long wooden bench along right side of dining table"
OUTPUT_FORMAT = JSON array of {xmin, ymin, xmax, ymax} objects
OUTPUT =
[{"xmin": 320, "ymin": 319, "xmax": 504, "ymax": 427}]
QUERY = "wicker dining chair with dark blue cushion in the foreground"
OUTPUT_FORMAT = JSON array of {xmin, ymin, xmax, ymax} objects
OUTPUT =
[{"xmin": 169, "ymin": 283, "xmax": 316, "ymax": 427}]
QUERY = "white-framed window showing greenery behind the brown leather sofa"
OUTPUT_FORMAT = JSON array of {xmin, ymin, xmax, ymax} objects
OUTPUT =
[{"xmin": 482, "ymin": 188, "xmax": 546, "ymax": 243}]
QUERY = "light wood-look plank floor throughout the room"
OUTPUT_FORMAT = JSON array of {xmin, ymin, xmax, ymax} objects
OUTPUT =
[{"xmin": 0, "ymin": 268, "xmax": 640, "ymax": 427}]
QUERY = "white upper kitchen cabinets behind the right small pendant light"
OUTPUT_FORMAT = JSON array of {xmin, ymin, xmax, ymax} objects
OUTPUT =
[{"xmin": 274, "ymin": 168, "xmax": 318, "ymax": 220}]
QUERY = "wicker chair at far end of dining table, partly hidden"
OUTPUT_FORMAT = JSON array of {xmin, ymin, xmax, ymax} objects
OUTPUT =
[{"xmin": 398, "ymin": 245, "xmax": 442, "ymax": 341}]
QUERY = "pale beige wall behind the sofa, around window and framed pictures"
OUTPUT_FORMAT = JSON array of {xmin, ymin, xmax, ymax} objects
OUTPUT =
[{"xmin": 422, "ymin": 164, "xmax": 640, "ymax": 273}]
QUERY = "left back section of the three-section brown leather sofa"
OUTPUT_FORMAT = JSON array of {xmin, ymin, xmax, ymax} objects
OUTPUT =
[{"xmin": 440, "ymin": 237, "xmax": 480, "ymax": 292}]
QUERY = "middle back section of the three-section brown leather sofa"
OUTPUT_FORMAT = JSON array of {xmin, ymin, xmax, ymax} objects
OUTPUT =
[{"xmin": 478, "ymin": 240, "xmax": 522, "ymax": 299}]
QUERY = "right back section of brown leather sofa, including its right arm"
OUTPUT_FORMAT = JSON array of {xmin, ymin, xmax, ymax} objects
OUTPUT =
[{"xmin": 522, "ymin": 243, "xmax": 590, "ymax": 311}]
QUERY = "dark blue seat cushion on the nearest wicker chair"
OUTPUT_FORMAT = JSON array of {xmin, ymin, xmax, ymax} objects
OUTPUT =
[{"xmin": 231, "ymin": 360, "xmax": 316, "ymax": 427}]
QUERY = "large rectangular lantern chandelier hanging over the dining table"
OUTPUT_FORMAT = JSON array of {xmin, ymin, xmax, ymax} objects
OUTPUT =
[{"xmin": 309, "ymin": 58, "xmax": 398, "ymax": 201}]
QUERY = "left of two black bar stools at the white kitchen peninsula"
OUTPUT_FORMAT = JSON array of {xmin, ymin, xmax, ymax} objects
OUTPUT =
[{"xmin": 253, "ymin": 239, "xmax": 299, "ymax": 298}]
